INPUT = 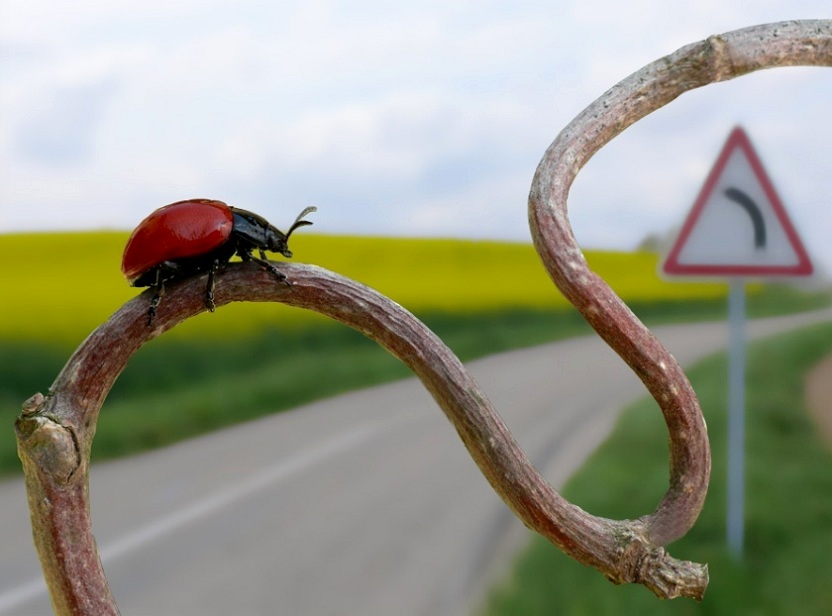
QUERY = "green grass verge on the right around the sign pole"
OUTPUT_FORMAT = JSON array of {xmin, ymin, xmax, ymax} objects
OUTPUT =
[{"xmin": 480, "ymin": 324, "xmax": 832, "ymax": 615}]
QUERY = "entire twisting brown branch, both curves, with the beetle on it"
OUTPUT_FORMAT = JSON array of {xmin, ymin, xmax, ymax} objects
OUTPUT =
[{"xmin": 16, "ymin": 21, "xmax": 832, "ymax": 616}]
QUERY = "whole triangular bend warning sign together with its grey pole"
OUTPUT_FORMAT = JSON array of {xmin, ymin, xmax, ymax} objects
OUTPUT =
[{"xmin": 662, "ymin": 127, "xmax": 812, "ymax": 558}]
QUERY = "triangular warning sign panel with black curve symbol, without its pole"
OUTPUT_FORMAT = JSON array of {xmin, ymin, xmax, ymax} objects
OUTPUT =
[{"xmin": 663, "ymin": 127, "xmax": 812, "ymax": 276}]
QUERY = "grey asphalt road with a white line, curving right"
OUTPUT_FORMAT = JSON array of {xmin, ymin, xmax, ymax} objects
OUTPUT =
[{"xmin": 0, "ymin": 311, "xmax": 832, "ymax": 616}]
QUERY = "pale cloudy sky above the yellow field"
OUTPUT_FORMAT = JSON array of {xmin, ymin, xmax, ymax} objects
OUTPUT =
[{"xmin": 0, "ymin": 0, "xmax": 832, "ymax": 271}]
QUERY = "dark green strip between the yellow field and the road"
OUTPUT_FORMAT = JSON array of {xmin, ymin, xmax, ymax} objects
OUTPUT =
[{"xmin": 0, "ymin": 289, "xmax": 828, "ymax": 475}]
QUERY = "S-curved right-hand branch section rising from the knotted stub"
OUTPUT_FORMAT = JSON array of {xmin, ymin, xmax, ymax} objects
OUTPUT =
[{"xmin": 529, "ymin": 20, "xmax": 832, "ymax": 545}]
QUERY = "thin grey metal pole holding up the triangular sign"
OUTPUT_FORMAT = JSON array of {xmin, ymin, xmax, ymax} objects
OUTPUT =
[{"xmin": 727, "ymin": 278, "xmax": 745, "ymax": 558}]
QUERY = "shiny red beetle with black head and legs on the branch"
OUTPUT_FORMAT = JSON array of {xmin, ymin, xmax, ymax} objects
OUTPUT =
[{"xmin": 121, "ymin": 199, "xmax": 317, "ymax": 324}]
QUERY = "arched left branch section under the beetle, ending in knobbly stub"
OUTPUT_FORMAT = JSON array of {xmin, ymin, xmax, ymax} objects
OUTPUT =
[{"xmin": 16, "ymin": 263, "xmax": 704, "ymax": 614}]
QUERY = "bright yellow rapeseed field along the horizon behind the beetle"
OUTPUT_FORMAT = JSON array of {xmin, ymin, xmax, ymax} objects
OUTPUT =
[{"xmin": 0, "ymin": 231, "xmax": 726, "ymax": 346}]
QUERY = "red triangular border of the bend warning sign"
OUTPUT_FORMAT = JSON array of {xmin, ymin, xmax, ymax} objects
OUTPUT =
[{"xmin": 662, "ymin": 126, "xmax": 814, "ymax": 276}]
